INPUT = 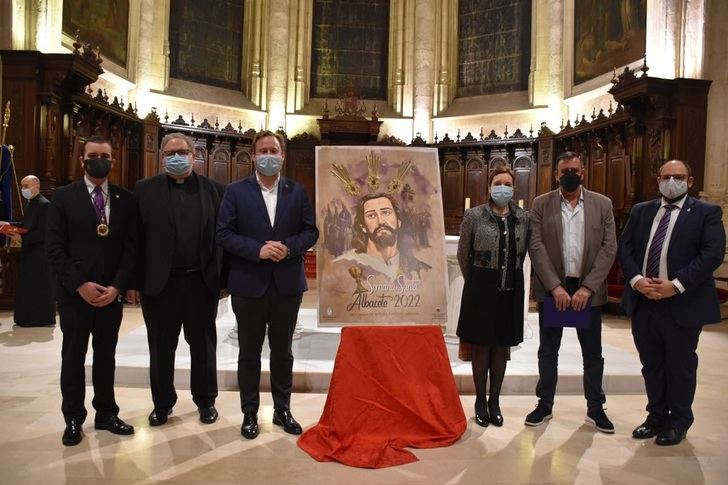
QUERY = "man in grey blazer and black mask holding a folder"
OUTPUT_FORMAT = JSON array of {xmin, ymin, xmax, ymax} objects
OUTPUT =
[{"xmin": 525, "ymin": 152, "xmax": 617, "ymax": 433}]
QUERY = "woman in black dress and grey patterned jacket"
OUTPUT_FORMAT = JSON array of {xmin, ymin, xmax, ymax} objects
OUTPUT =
[{"xmin": 457, "ymin": 167, "xmax": 529, "ymax": 426}]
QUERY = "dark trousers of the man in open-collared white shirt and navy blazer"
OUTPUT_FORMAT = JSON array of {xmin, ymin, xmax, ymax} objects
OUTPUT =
[{"xmin": 232, "ymin": 284, "xmax": 303, "ymax": 413}]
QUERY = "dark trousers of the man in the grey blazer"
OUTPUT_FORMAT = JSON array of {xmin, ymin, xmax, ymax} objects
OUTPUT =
[{"xmin": 536, "ymin": 278, "xmax": 606, "ymax": 409}]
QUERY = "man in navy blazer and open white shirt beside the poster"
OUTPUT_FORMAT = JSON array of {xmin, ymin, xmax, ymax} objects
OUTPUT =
[{"xmin": 217, "ymin": 131, "xmax": 318, "ymax": 439}]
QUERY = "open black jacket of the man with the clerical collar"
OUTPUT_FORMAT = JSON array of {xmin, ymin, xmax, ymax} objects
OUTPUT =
[{"xmin": 134, "ymin": 173, "xmax": 225, "ymax": 296}]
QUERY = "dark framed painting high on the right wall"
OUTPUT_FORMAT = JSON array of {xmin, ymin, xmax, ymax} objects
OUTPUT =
[{"xmin": 574, "ymin": 0, "xmax": 647, "ymax": 85}]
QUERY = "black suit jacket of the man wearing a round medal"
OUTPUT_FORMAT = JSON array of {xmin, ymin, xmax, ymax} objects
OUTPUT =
[{"xmin": 46, "ymin": 179, "xmax": 138, "ymax": 303}]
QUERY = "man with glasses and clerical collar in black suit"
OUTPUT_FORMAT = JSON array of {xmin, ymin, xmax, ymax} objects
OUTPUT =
[{"xmin": 130, "ymin": 133, "xmax": 225, "ymax": 426}]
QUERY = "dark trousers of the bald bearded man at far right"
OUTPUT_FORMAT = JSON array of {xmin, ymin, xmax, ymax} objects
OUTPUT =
[{"xmin": 632, "ymin": 300, "xmax": 703, "ymax": 431}]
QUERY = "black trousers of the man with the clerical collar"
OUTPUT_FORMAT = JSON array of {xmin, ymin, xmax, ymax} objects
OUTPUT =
[{"xmin": 142, "ymin": 272, "xmax": 219, "ymax": 409}]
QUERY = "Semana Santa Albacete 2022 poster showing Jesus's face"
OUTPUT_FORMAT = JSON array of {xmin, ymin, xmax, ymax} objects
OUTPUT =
[{"xmin": 316, "ymin": 146, "xmax": 447, "ymax": 326}]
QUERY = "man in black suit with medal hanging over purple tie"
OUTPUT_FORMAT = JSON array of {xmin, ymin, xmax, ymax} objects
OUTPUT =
[{"xmin": 46, "ymin": 136, "xmax": 138, "ymax": 446}]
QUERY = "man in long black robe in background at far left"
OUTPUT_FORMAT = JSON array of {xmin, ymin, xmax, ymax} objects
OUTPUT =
[{"xmin": 0, "ymin": 175, "xmax": 56, "ymax": 327}]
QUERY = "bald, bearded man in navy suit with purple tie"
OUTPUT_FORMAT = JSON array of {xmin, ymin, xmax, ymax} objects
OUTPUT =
[{"xmin": 619, "ymin": 160, "xmax": 725, "ymax": 445}]
